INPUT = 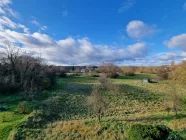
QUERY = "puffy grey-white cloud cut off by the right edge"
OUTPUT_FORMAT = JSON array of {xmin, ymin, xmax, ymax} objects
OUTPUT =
[{"xmin": 164, "ymin": 34, "xmax": 186, "ymax": 51}]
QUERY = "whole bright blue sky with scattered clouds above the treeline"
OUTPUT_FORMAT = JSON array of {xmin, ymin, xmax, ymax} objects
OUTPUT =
[{"xmin": 0, "ymin": 0, "xmax": 186, "ymax": 66}]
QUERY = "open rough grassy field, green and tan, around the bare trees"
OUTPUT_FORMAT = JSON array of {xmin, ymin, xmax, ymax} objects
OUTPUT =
[{"xmin": 0, "ymin": 74, "xmax": 186, "ymax": 140}]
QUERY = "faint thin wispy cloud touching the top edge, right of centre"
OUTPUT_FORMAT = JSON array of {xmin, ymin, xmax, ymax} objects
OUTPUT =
[{"xmin": 118, "ymin": 0, "xmax": 136, "ymax": 13}]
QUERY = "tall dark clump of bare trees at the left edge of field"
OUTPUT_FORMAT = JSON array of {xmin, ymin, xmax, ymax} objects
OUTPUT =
[{"xmin": 0, "ymin": 42, "xmax": 55, "ymax": 98}]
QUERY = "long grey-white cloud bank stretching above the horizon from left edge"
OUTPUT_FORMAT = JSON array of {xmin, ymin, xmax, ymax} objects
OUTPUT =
[{"xmin": 0, "ymin": 29, "xmax": 147, "ymax": 65}]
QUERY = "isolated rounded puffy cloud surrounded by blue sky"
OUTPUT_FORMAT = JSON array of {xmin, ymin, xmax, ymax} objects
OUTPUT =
[{"xmin": 126, "ymin": 20, "xmax": 154, "ymax": 38}]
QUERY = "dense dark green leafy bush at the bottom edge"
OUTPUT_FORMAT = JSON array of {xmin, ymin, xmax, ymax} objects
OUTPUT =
[{"xmin": 128, "ymin": 124, "xmax": 182, "ymax": 140}]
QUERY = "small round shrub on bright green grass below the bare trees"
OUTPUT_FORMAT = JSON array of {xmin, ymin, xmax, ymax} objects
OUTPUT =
[{"xmin": 17, "ymin": 101, "xmax": 32, "ymax": 114}]
